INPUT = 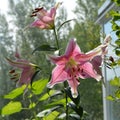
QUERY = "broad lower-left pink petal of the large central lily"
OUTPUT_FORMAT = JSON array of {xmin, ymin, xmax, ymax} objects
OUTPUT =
[{"xmin": 47, "ymin": 65, "xmax": 70, "ymax": 88}]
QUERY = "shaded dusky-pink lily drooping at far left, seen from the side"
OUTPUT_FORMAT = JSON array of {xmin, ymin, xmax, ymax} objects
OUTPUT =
[{"xmin": 6, "ymin": 51, "xmax": 38, "ymax": 85}]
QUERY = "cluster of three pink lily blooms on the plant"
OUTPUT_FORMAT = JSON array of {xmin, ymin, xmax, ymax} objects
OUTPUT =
[{"xmin": 7, "ymin": 3, "xmax": 110, "ymax": 98}]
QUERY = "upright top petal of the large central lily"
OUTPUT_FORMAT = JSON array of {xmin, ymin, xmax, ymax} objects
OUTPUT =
[{"xmin": 65, "ymin": 39, "xmax": 81, "ymax": 57}]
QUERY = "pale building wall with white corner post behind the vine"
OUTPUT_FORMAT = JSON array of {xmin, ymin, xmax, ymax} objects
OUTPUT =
[{"xmin": 96, "ymin": 0, "xmax": 120, "ymax": 120}]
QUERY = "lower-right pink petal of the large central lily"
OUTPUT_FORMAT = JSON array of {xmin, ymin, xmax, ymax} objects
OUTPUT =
[{"xmin": 79, "ymin": 62, "xmax": 102, "ymax": 81}]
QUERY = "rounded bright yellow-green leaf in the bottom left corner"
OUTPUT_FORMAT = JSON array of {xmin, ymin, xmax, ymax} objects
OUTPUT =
[{"xmin": 1, "ymin": 101, "xmax": 22, "ymax": 115}]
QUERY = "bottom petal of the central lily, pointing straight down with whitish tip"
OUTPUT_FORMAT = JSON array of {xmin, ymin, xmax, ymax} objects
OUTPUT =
[{"xmin": 67, "ymin": 78, "xmax": 80, "ymax": 98}]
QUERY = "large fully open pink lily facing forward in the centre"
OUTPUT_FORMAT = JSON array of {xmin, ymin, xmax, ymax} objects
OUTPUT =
[{"xmin": 48, "ymin": 35, "xmax": 108, "ymax": 98}]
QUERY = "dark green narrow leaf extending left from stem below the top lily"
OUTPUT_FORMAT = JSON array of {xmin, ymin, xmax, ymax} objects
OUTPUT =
[{"xmin": 32, "ymin": 44, "xmax": 57, "ymax": 54}]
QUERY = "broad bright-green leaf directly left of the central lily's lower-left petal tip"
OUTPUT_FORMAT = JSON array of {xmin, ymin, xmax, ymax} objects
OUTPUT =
[{"xmin": 32, "ymin": 79, "xmax": 48, "ymax": 95}]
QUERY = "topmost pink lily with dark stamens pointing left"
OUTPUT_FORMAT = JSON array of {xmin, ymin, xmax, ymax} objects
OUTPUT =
[{"xmin": 30, "ymin": 3, "xmax": 61, "ymax": 29}]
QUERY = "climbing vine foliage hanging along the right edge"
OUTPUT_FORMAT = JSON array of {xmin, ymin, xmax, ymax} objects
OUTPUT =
[{"xmin": 107, "ymin": 0, "xmax": 120, "ymax": 101}]
